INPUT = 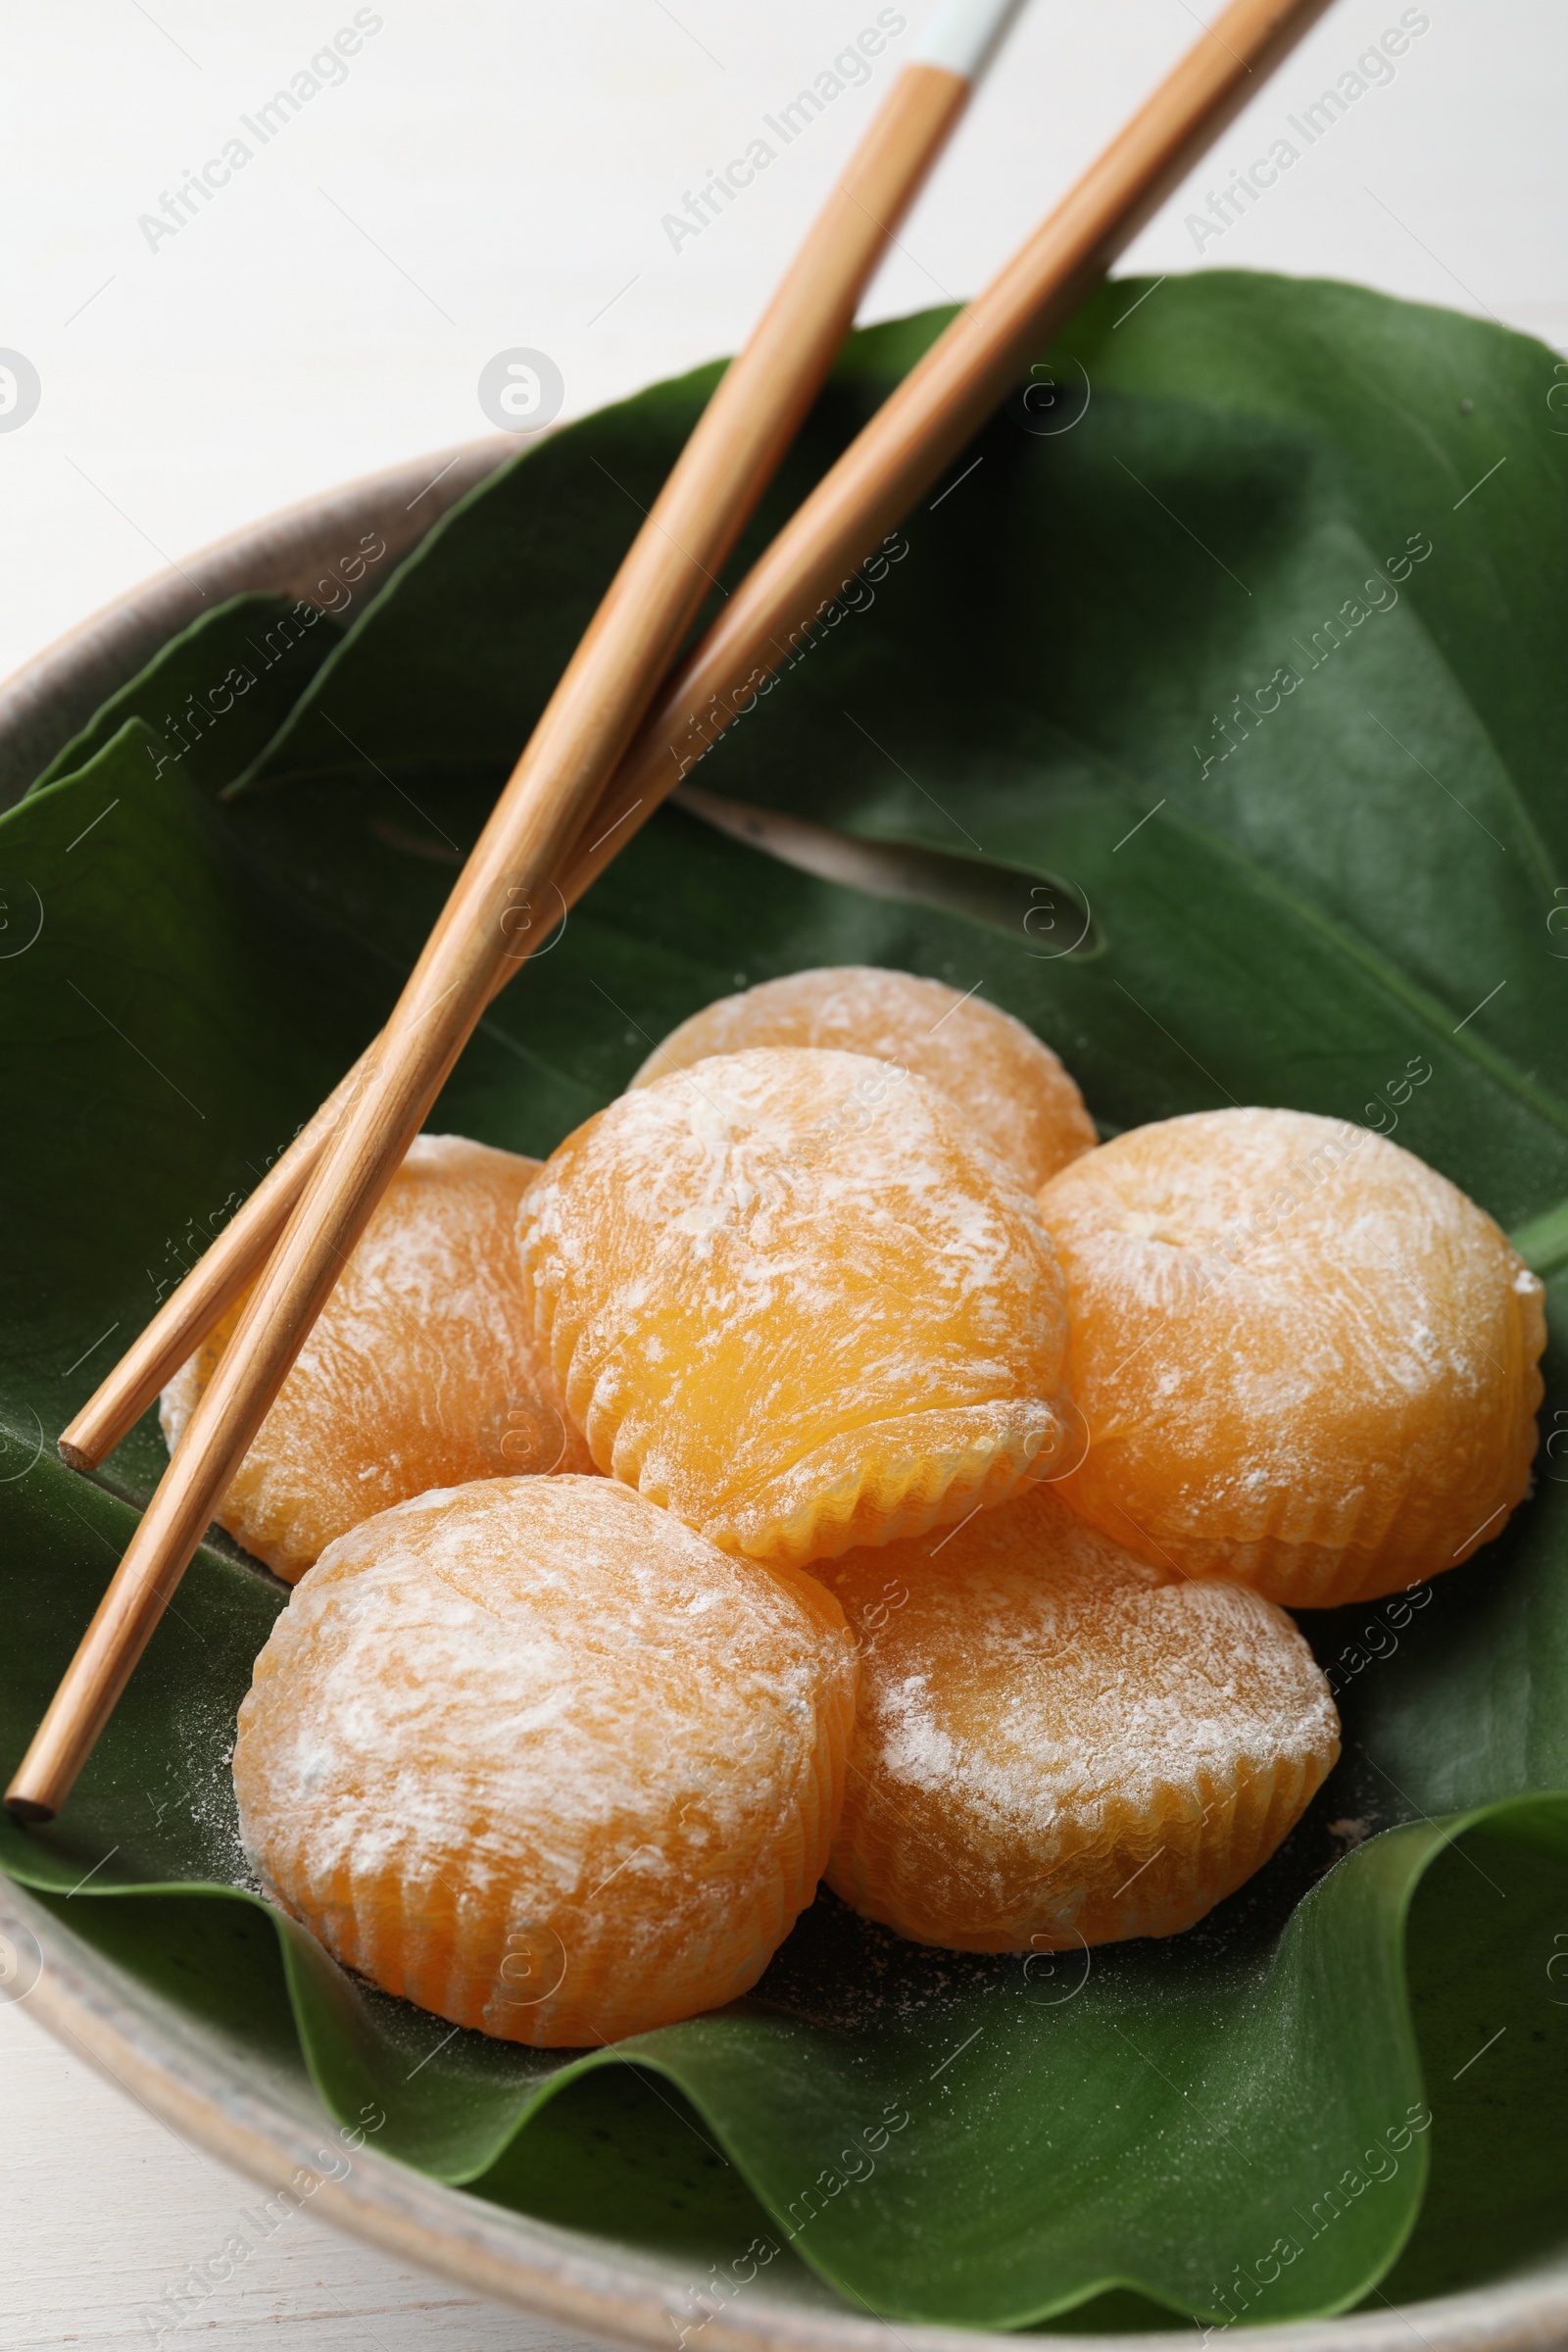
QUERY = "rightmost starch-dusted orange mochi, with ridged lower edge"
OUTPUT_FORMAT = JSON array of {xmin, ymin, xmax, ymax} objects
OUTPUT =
[{"xmin": 1039, "ymin": 1110, "xmax": 1546, "ymax": 1609}]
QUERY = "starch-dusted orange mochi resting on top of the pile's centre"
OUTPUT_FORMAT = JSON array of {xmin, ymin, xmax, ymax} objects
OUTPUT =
[{"xmin": 519, "ymin": 1047, "xmax": 1067, "ymax": 1566}]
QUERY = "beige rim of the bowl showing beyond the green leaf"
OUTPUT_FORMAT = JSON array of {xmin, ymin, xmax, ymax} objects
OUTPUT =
[{"xmin": 0, "ymin": 435, "xmax": 1568, "ymax": 2352}]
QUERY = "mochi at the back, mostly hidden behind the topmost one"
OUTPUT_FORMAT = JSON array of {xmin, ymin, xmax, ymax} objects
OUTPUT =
[{"xmin": 632, "ymin": 964, "xmax": 1098, "ymax": 1190}]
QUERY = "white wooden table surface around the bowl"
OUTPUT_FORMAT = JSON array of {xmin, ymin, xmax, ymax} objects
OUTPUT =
[{"xmin": 0, "ymin": 0, "xmax": 1568, "ymax": 2352}]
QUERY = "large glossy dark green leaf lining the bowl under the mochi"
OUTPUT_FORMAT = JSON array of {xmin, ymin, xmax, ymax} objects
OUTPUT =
[{"xmin": 0, "ymin": 272, "xmax": 1568, "ymax": 2327}]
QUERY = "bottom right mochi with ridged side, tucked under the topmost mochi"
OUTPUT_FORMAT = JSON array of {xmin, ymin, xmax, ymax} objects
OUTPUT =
[{"xmin": 818, "ymin": 1487, "xmax": 1340, "ymax": 1947}]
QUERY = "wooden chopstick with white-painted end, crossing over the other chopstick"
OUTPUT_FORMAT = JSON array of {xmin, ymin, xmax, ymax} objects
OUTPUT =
[{"xmin": 7, "ymin": 0, "xmax": 1020, "ymax": 1821}]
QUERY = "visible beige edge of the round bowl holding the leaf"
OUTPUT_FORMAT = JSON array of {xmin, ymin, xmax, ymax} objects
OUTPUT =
[{"xmin": 0, "ymin": 414, "xmax": 1568, "ymax": 2352}]
